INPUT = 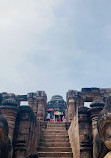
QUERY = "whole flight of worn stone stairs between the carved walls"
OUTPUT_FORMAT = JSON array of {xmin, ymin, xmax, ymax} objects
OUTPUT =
[{"xmin": 38, "ymin": 122, "xmax": 73, "ymax": 158}]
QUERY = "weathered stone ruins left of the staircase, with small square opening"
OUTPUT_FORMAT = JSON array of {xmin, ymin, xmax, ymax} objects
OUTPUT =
[{"xmin": 0, "ymin": 91, "xmax": 47, "ymax": 158}]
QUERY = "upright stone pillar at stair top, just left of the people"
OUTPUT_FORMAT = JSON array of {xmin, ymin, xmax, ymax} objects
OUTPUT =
[{"xmin": 36, "ymin": 91, "xmax": 47, "ymax": 121}]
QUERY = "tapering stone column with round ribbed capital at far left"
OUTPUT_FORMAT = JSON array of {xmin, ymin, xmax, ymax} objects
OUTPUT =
[{"xmin": 0, "ymin": 99, "xmax": 19, "ymax": 143}]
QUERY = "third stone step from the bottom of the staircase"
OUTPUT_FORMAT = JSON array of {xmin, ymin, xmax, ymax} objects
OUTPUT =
[{"xmin": 39, "ymin": 142, "xmax": 70, "ymax": 147}]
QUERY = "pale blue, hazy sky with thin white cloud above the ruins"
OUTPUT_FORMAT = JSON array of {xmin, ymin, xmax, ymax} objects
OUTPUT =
[{"xmin": 0, "ymin": 0, "xmax": 111, "ymax": 99}]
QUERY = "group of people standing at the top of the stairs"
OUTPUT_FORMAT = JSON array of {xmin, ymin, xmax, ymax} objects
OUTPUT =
[{"xmin": 46, "ymin": 112, "xmax": 66, "ymax": 122}]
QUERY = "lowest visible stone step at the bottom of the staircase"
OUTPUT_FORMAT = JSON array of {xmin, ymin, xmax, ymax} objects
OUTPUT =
[{"xmin": 38, "ymin": 152, "xmax": 73, "ymax": 157}]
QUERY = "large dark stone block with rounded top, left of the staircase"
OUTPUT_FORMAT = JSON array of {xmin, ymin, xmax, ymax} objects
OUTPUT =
[{"xmin": 13, "ymin": 106, "xmax": 40, "ymax": 158}]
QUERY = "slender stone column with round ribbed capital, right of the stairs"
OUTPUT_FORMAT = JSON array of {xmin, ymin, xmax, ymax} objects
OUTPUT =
[{"xmin": 89, "ymin": 100, "xmax": 104, "ymax": 158}]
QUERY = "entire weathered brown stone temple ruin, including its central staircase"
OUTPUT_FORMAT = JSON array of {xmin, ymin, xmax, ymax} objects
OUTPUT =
[{"xmin": 0, "ymin": 88, "xmax": 111, "ymax": 158}]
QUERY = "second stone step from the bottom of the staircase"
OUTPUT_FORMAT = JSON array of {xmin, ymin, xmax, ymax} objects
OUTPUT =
[{"xmin": 38, "ymin": 147, "xmax": 72, "ymax": 152}]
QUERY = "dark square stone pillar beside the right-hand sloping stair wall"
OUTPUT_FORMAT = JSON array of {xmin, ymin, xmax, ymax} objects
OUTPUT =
[{"xmin": 78, "ymin": 107, "xmax": 92, "ymax": 158}]
